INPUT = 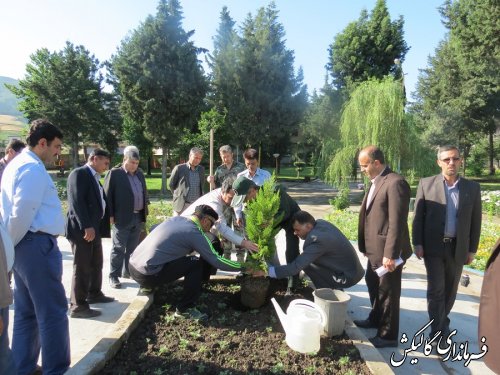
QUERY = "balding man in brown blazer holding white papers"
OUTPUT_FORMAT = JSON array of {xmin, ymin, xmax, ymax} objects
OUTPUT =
[{"xmin": 354, "ymin": 146, "xmax": 412, "ymax": 348}]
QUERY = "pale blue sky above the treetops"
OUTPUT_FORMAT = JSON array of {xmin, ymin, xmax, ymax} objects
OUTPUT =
[{"xmin": 0, "ymin": 0, "xmax": 446, "ymax": 98}]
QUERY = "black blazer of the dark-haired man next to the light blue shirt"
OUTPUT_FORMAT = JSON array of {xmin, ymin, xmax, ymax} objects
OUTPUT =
[{"xmin": 66, "ymin": 165, "xmax": 110, "ymax": 241}]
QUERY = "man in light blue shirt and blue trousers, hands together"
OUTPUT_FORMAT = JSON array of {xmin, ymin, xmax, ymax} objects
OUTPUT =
[{"xmin": 1, "ymin": 120, "xmax": 70, "ymax": 374}]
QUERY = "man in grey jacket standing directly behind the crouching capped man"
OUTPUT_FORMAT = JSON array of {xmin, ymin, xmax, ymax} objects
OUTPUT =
[{"xmin": 168, "ymin": 147, "xmax": 205, "ymax": 216}]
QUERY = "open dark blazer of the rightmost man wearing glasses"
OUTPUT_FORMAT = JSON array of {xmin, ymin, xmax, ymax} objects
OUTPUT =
[{"xmin": 412, "ymin": 175, "xmax": 481, "ymax": 264}]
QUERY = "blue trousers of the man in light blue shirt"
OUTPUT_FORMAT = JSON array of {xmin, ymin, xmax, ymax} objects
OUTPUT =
[{"xmin": 12, "ymin": 232, "xmax": 71, "ymax": 375}]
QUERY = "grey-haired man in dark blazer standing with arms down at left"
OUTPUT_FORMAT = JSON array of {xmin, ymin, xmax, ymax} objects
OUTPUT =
[{"xmin": 104, "ymin": 146, "xmax": 149, "ymax": 289}]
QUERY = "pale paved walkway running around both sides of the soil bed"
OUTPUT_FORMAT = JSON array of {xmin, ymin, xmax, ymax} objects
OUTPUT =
[{"xmin": 5, "ymin": 181, "xmax": 492, "ymax": 375}]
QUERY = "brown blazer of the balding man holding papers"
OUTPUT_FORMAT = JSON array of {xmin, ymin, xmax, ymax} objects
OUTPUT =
[{"xmin": 358, "ymin": 168, "xmax": 412, "ymax": 266}]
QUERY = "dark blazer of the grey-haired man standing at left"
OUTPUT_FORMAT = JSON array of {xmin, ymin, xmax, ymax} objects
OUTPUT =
[{"xmin": 104, "ymin": 165, "xmax": 149, "ymax": 225}]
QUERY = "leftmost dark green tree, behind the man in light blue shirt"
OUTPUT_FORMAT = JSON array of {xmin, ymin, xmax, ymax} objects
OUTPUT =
[{"xmin": 8, "ymin": 42, "xmax": 112, "ymax": 167}]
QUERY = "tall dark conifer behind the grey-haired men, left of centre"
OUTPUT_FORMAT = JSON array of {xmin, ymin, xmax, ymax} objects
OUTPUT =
[{"xmin": 112, "ymin": 0, "xmax": 207, "ymax": 193}]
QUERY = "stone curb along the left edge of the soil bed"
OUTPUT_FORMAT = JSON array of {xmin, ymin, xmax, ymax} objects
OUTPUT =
[{"xmin": 66, "ymin": 294, "xmax": 154, "ymax": 375}]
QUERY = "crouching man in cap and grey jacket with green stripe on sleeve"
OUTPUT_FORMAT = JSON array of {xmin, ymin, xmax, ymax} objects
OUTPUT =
[{"xmin": 129, "ymin": 205, "xmax": 246, "ymax": 320}]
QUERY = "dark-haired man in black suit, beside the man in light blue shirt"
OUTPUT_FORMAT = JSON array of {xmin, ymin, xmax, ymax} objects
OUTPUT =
[{"xmin": 66, "ymin": 148, "xmax": 114, "ymax": 318}]
